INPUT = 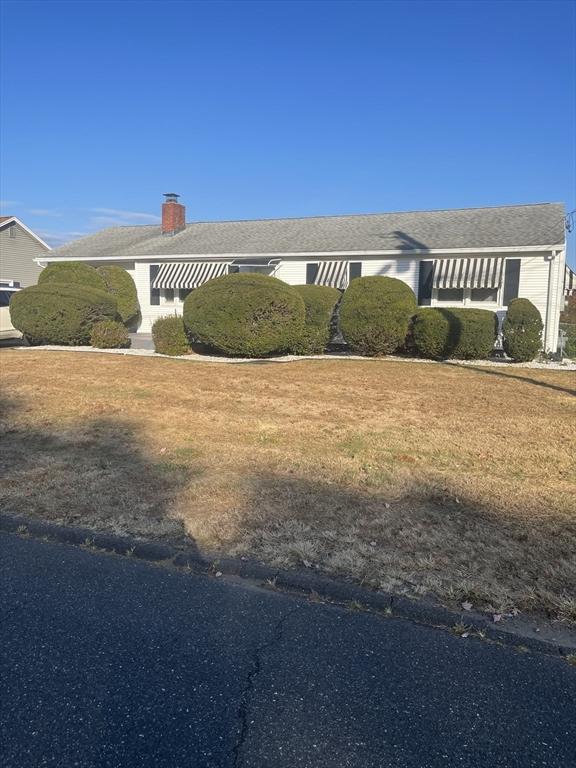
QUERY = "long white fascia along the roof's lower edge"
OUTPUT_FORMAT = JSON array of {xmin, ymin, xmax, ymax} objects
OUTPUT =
[{"xmin": 34, "ymin": 243, "xmax": 564, "ymax": 263}]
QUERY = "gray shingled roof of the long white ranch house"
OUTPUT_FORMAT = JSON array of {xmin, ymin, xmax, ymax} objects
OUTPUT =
[{"xmin": 46, "ymin": 203, "xmax": 564, "ymax": 259}]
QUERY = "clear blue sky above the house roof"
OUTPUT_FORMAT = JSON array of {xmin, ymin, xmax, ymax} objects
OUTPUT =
[{"xmin": 1, "ymin": 0, "xmax": 576, "ymax": 262}]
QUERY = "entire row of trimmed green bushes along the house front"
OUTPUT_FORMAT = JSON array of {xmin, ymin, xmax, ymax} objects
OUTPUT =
[{"xmin": 11, "ymin": 263, "xmax": 542, "ymax": 361}]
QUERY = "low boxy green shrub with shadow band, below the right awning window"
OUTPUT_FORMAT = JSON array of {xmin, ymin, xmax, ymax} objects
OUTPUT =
[{"xmin": 412, "ymin": 307, "xmax": 498, "ymax": 360}]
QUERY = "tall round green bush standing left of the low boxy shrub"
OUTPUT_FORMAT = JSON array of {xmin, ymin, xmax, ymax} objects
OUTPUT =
[{"xmin": 340, "ymin": 276, "xmax": 417, "ymax": 355}]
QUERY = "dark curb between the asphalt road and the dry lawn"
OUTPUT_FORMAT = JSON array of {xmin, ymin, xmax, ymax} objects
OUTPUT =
[{"xmin": 0, "ymin": 514, "xmax": 576, "ymax": 656}]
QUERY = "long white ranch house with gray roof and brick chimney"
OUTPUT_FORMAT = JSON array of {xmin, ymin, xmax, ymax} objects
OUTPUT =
[{"xmin": 38, "ymin": 194, "xmax": 566, "ymax": 351}]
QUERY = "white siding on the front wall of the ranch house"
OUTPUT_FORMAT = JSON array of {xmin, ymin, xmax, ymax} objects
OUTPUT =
[{"xmin": 50, "ymin": 251, "xmax": 565, "ymax": 350}]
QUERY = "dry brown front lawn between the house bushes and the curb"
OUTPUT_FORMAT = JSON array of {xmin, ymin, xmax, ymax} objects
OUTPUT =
[{"xmin": 0, "ymin": 350, "xmax": 576, "ymax": 621}]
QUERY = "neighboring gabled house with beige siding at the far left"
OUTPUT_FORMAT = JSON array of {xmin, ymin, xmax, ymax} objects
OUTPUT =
[{"xmin": 0, "ymin": 216, "xmax": 52, "ymax": 288}]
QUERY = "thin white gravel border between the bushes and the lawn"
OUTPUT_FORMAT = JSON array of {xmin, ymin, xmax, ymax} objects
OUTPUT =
[{"xmin": 14, "ymin": 344, "xmax": 576, "ymax": 371}]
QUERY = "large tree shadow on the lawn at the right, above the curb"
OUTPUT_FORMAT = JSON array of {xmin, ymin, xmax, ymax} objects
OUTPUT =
[{"xmin": 196, "ymin": 474, "xmax": 576, "ymax": 621}]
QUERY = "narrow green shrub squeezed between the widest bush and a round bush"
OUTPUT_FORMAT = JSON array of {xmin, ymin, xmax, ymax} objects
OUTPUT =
[{"xmin": 291, "ymin": 285, "xmax": 341, "ymax": 355}]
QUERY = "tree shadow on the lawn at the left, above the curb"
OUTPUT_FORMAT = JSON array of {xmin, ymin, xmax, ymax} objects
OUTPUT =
[{"xmin": 0, "ymin": 396, "xmax": 203, "ymax": 546}]
